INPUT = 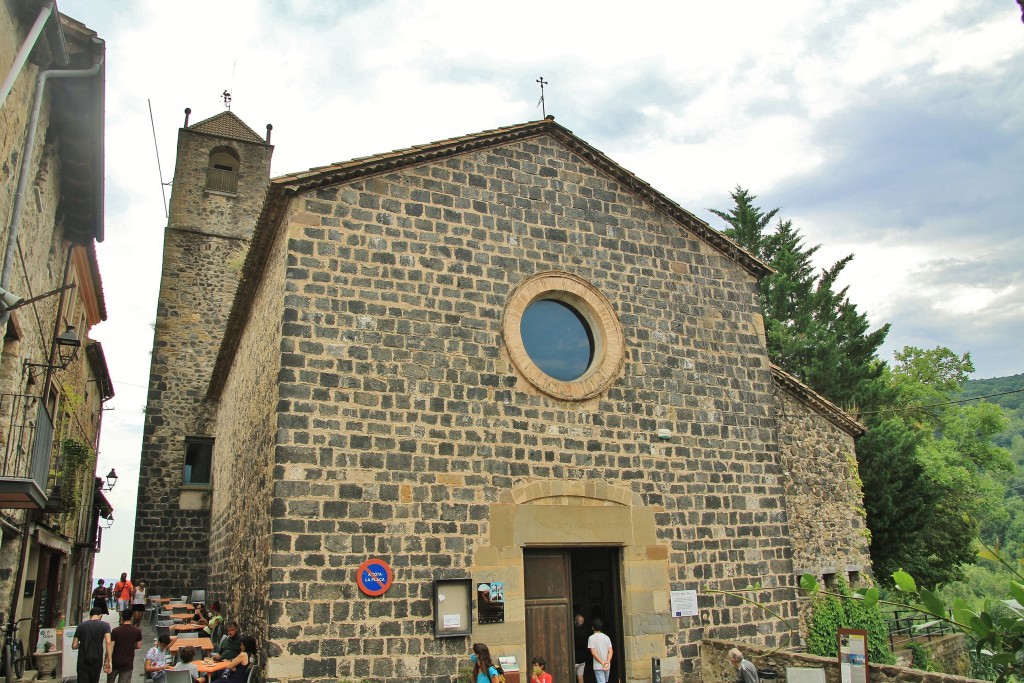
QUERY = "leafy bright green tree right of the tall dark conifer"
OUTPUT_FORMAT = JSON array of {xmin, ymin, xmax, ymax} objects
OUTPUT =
[{"xmin": 857, "ymin": 346, "xmax": 1014, "ymax": 587}]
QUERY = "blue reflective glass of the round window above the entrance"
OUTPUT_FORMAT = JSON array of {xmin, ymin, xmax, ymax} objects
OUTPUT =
[{"xmin": 519, "ymin": 299, "xmax": 594, "ymax": 382}]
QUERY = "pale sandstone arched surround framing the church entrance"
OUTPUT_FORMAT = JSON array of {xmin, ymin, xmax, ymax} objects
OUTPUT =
[{"xmin": 472, "ymin": 480, "xmax": 678, "ymax": 681}]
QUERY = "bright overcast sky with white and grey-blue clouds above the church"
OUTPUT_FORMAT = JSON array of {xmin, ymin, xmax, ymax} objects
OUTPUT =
[{"xmin": 58, "ymin": 0, "xmax": 1024, "ymax": 577}]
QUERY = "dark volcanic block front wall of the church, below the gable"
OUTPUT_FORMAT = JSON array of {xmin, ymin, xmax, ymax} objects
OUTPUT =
[{"xmin": 216, "ymin": 136, "xmax": 796, "ymax": 683}]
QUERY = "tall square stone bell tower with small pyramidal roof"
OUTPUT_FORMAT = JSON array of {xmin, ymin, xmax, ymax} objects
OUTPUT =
[{"xmin": 131, "ymin": 110, "xmax": 273, "ymax": 595}]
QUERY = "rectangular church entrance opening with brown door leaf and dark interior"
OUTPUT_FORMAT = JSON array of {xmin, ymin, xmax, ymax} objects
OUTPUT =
[{"xmin": 523, "ymin": 548, "xmax": 626, "ymax": 683}]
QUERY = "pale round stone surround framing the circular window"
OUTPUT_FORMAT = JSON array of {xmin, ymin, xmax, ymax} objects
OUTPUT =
[{"xmin": 502, "ymin": 270, "xmax": 626, "ymax": 400}]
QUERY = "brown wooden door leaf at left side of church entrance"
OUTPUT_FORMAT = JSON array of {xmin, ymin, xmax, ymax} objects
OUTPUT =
[{"xmin": 519, "ymin": 549, "xmax": 575, "ymax": 681}]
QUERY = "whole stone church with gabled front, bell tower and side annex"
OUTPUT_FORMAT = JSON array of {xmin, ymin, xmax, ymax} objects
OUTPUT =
[{"xmin": 133, "ymin": 113, "xmax": 869, "ymax": 682}]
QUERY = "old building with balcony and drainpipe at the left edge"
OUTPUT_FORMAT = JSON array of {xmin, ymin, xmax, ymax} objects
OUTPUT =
[{"xmin": 0, "ymin": 0, "xmax": 114, "ymax": 651}]
